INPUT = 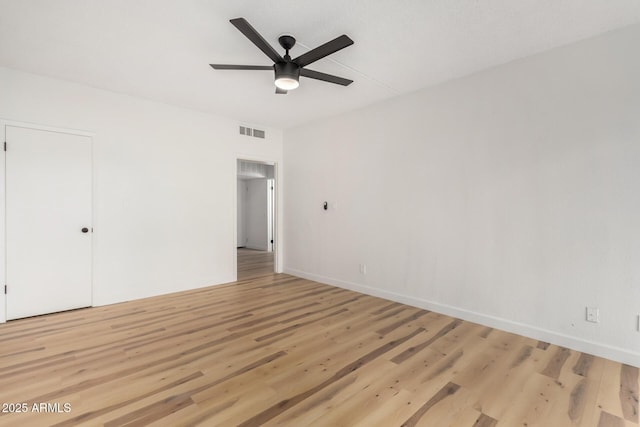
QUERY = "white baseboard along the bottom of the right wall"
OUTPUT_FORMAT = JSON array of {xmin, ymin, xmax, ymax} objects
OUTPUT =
[{"xmin": 284, "ymin": 267, "xmax": 640, "ymax": 367}]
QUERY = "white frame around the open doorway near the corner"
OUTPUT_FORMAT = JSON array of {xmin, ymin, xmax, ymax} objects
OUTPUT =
[{"xmin": 232, "ymin": 154, "xmax": 283, "ymax": 280}]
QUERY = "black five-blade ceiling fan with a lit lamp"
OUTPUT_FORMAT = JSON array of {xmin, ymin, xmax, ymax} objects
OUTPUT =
[{"xmin": 209, "ymin": 18, "xmax": 353, "ymax": 94}]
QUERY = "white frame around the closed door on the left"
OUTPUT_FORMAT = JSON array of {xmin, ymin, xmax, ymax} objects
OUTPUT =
[{"xmin": 0, "ymin": 118, "xmax": 96, "ymax": 323}]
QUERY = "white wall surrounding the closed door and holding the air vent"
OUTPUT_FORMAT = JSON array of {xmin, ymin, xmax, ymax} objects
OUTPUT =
[{"xmin": 0, "ymin": 68, "xmax": 282, "ymax": 321}]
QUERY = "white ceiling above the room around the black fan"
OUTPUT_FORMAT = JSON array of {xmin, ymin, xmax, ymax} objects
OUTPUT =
[{"xmin": 0, "ymin": 0, "xmax": 640, "ymax": 128}]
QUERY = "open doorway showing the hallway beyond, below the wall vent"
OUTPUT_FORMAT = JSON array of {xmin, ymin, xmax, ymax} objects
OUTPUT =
[{"xmin": 236, "ymin": 159, "xmax": 277, "ymax": 280}]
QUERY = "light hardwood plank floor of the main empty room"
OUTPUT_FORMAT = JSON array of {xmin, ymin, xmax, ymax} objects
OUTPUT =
[{"xmin": 0, "ymin": 252, "xmax": 639, "ymax": 427}]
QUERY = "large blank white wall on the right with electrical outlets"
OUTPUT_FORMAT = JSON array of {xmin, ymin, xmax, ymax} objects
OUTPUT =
[{"xmin": 284, "ymin": 25, "xmax": 640, "ymax": 366}]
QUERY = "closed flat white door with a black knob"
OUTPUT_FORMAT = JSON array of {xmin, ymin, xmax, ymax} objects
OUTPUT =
[{"xmin": 5, "ymin": 126, "xmax": 92, "ymax": 319}]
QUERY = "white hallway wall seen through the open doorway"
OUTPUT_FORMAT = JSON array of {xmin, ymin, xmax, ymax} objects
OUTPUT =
[{"xmin": 246, "ymin": 178, "xmax": 269, "ymax": 251}]
